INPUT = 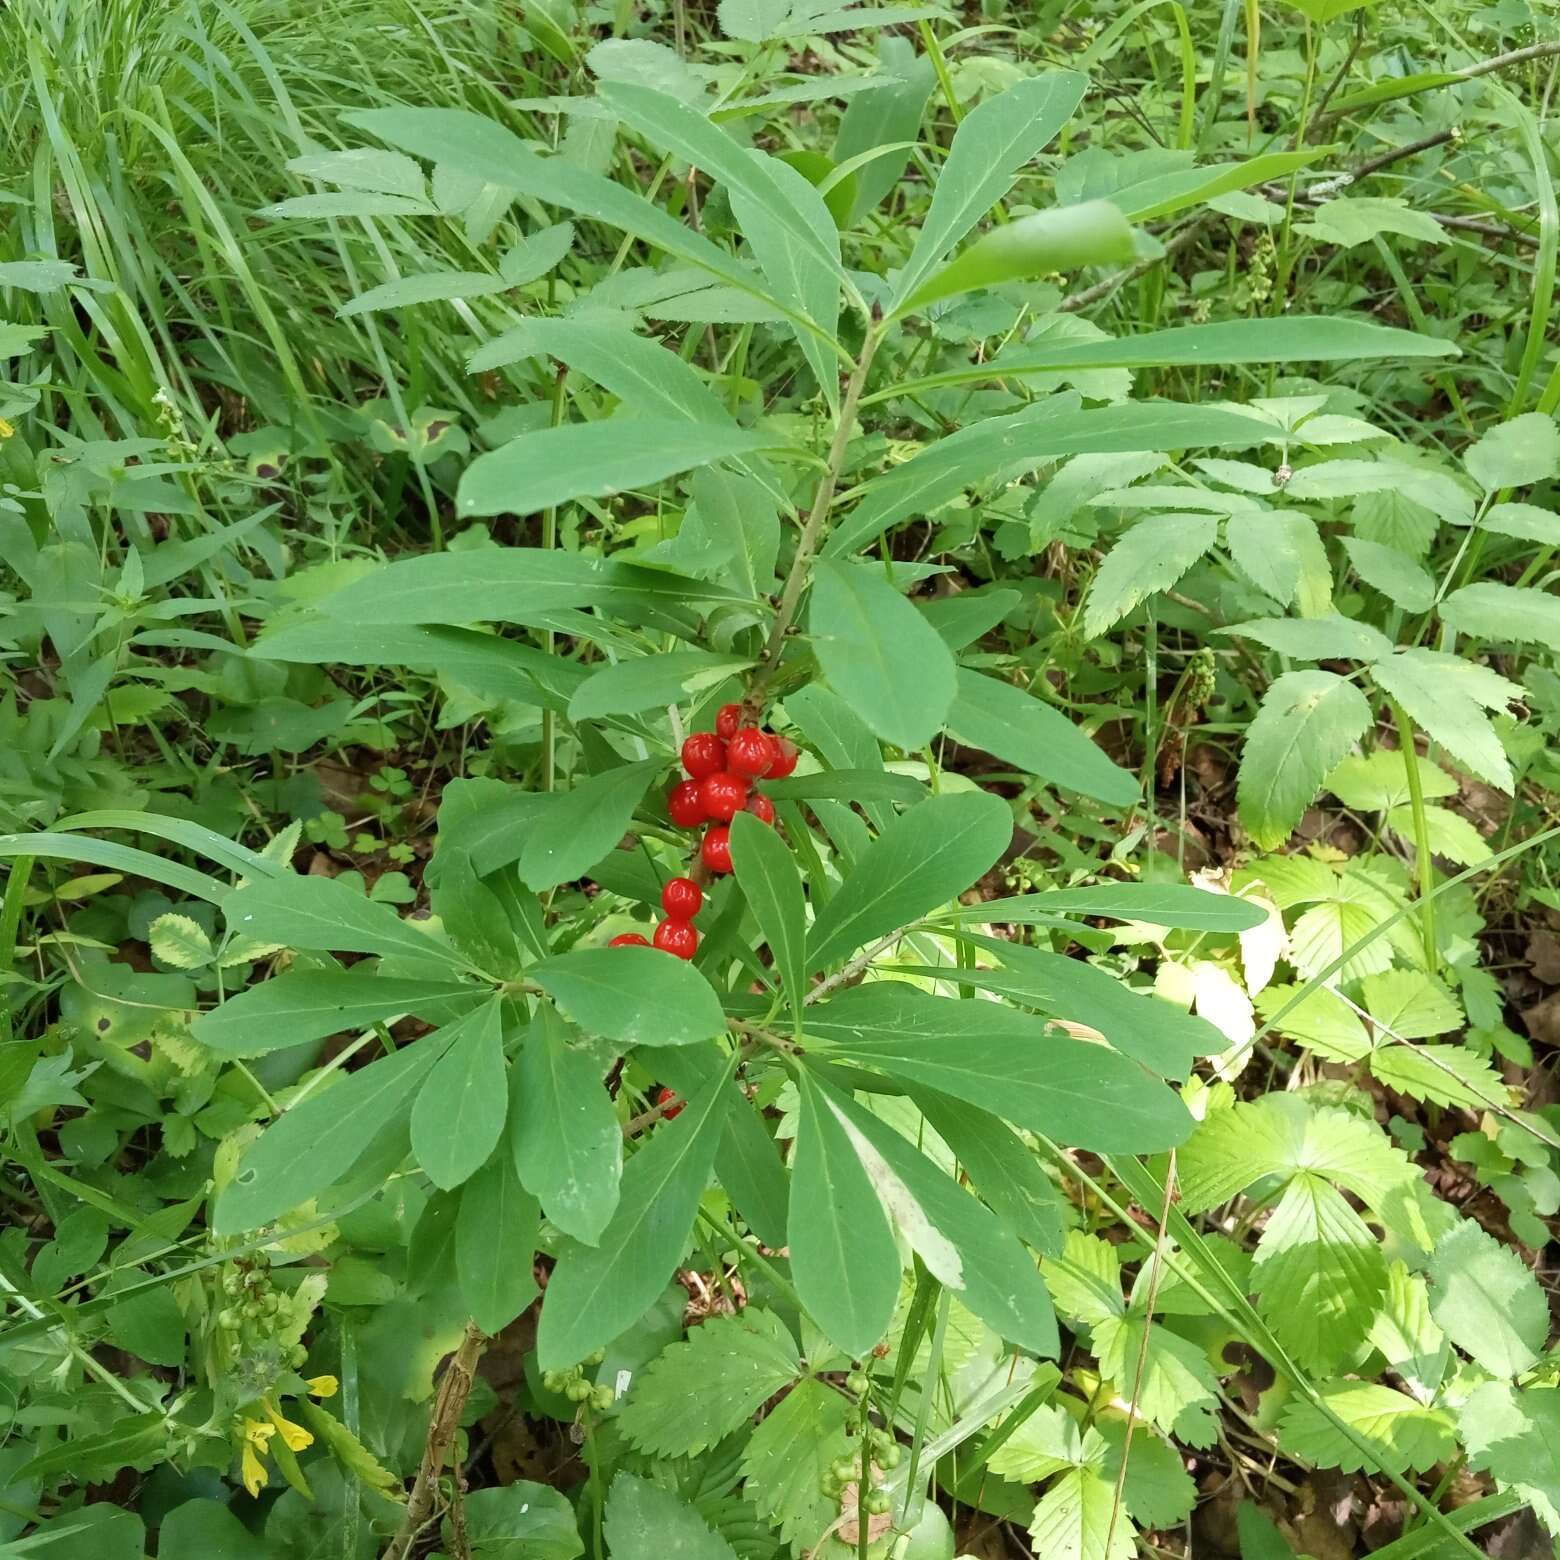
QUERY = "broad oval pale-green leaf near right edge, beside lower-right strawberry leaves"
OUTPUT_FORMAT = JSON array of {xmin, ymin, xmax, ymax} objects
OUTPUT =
[{"xmin": 1429, "ymin": 1220, "xmax": 1549, "ymax": 1376}]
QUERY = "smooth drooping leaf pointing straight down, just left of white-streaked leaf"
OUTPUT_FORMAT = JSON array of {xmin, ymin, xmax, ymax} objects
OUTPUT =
[{"xmin": 789, "ymin": 1072, "xmax": 899, "ymax": 1359}]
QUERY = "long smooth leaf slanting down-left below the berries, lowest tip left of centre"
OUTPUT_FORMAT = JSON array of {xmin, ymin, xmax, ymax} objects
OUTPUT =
[{"xmin": 537, "ymin": 1060, "xmax": 730, "ymax": 1370}]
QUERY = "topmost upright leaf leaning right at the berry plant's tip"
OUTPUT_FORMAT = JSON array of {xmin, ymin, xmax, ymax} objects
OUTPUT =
[{"xmin": 889, "ymin": 70, "xmax": 1087, "ymax": 315}]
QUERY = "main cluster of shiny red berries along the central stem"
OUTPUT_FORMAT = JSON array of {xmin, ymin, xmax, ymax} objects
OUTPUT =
[{"xmin": 608, "ymin": 704, "xmax": 797, "ymax": 959}]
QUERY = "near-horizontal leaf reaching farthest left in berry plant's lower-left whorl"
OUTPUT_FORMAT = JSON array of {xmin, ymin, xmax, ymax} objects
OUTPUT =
[{"xmin": 192, "ymin": 970, "xmax": 487, "ymax": 1056}]
